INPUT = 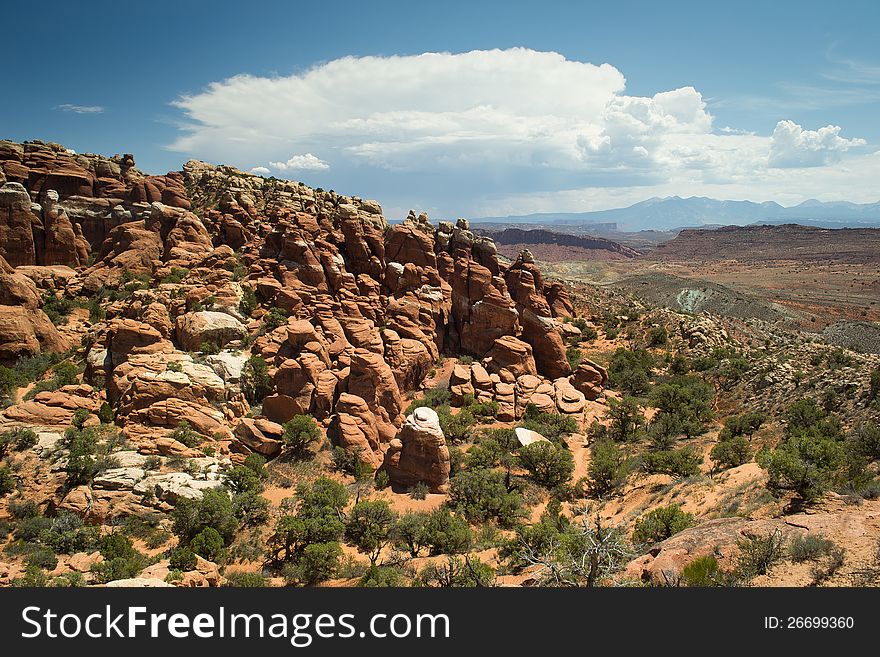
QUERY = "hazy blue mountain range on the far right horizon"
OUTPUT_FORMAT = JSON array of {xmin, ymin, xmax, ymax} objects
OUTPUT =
[{"xmin": 471, "ymin": 196, "xmax": 880, "ymax": 232}]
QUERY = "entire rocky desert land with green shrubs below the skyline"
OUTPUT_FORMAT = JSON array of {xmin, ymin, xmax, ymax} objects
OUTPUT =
[{"xmin": 0, "ymin": 136, "xmax": 880, "ymax": 586}]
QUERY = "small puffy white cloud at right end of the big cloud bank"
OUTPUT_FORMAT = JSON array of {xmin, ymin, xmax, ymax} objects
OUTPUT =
[{"xmin": 770, "ymin": 121, "xmax": 867, "ymax": 169}]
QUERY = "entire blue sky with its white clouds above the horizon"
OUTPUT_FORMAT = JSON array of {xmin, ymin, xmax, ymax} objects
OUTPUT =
[{"xmin": 0, "ymin": 0, "xmax": 880, "ymax": 217}]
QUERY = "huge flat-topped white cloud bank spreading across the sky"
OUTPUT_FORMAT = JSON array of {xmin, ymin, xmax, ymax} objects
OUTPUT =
[{"xmin": 171, "ymin": 48, "xmax": 876, "ymax": 216}]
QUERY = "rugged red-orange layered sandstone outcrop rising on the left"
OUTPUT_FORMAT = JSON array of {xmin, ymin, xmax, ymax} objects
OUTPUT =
[{"xmin": 0, "ymin": 142, "xmax": 583, "ymax": 476}]
